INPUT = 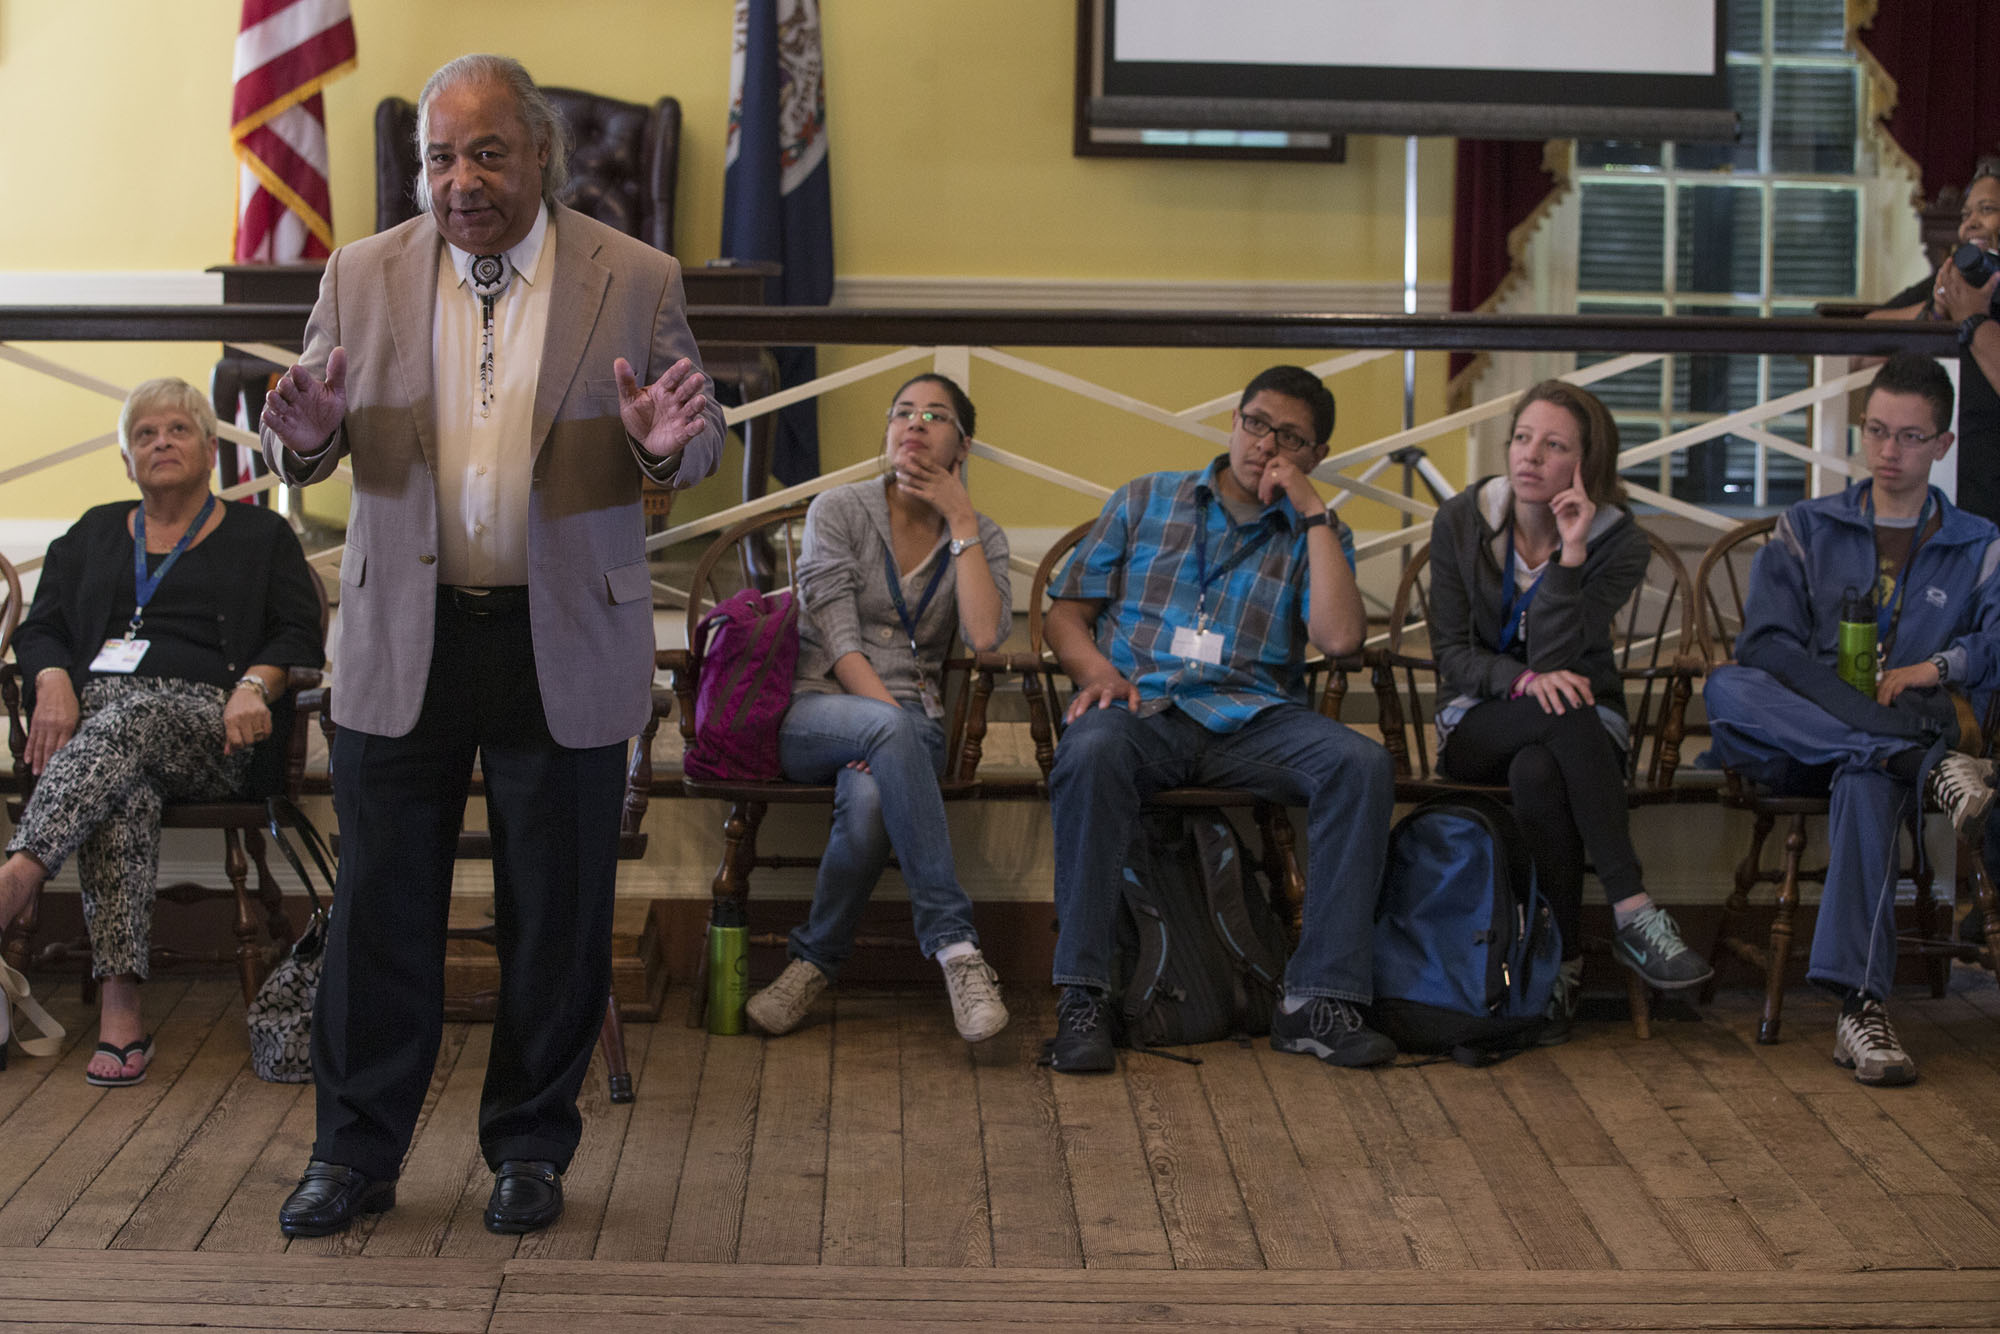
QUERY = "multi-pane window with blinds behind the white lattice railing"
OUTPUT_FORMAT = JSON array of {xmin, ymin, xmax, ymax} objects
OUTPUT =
[{"xmin": 1574, "ymin": 0, "xmax": 1864, "ymax": 510}]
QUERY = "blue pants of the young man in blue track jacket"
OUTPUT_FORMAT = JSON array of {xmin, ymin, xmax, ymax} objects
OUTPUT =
[{"xmin": 1702, "ymin": 664, "xmax": 1918, "ymax": 998}]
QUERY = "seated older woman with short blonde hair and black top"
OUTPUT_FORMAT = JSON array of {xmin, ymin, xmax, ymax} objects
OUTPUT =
[{"xmin": 0, "ymin": 380, "xmax": 324, "ymax": 1086}]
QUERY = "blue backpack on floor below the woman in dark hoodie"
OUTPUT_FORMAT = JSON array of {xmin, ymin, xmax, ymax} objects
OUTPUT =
[{"xmin": 1370, "ymin": 792, "xmax": 1562, "ymax": 1066}]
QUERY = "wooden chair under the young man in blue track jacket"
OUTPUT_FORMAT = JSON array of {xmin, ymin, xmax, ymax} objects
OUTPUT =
[{"xmin": 1694, "ymin": 516, "xmax": 2000, "ymax": 1042}]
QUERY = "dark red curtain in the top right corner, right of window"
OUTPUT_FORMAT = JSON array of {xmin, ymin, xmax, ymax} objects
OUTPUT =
[{"xmin": 1856, "ymin": 0, "xmax": 2000, "ymax": 200}]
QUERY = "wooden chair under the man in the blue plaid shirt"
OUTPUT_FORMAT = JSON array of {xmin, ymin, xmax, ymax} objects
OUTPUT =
[{"xmin": 1028, "ymin": 520, "xmax": 1360, "ymax": 940}]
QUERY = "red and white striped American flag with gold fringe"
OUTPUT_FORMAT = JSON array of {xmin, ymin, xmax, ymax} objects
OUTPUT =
[{"xmin": 230, "ymin": 0, "xmax": 354, "ymax": 264}]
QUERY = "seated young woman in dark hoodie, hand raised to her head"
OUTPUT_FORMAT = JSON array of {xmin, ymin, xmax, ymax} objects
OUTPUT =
[{"xmin": 1430, "ymin": 380, "xmax": 1710, "ymax": 1042}]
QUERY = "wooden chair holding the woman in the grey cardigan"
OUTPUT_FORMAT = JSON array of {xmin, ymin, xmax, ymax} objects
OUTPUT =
[{"xmin": 658, "ymin": 504, "xmax": 1032, "ymax": 1026}]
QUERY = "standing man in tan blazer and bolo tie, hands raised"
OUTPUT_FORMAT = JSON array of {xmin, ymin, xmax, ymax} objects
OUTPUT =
[{"xmin": 264, "ymin": 56, "xmax": 722, "ymax": 1236}]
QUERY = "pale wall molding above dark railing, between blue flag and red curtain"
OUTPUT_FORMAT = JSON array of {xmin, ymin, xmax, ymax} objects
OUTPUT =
[{"xmin": 834, "ymin": 274, "xmax": 1450, "ymax": 314}]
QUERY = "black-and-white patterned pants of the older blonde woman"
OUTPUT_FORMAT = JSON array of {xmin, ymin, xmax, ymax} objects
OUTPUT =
[{"xmin": 6, "ymin": 676, "xmax": 250, "ymax": 978}]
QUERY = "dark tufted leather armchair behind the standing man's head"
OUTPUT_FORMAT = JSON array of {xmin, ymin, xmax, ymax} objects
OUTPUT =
[{"xmin": 376, "ymin": 88, "xmax": 680, "ymax": 254}]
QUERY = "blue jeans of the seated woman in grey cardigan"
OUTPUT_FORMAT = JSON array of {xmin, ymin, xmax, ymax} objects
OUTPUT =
[{"xmin": 778, "ymin": 694, "xmax": 978, "ymax": 978}]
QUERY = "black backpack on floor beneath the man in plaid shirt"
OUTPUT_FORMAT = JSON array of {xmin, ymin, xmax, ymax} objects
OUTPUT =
[{"xmin": 1112, "ymin": 808, "xmax": 1292, "ymax": 1046}]
